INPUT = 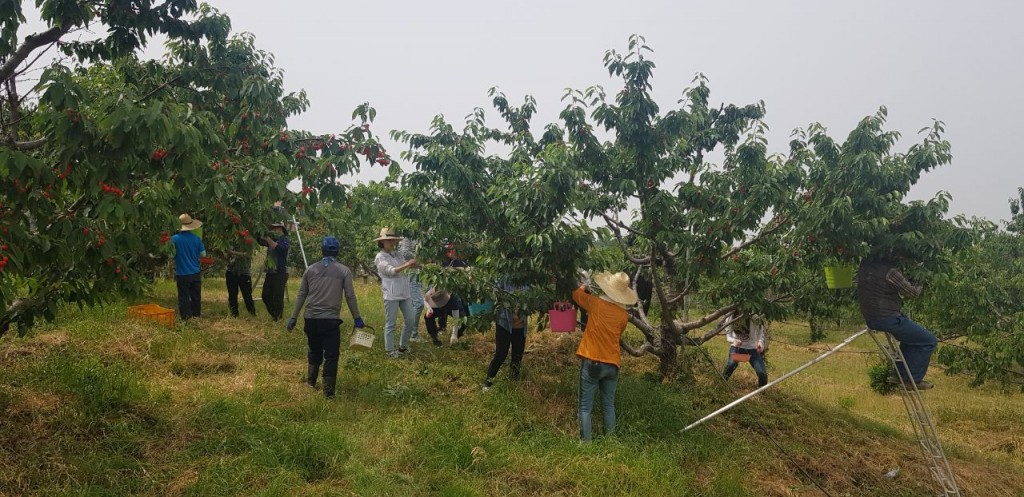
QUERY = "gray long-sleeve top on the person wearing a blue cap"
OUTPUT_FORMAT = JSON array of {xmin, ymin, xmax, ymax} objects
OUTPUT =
[{"xmin": 292, "ymin": 260, "xmax": 361, "ymax": 320}]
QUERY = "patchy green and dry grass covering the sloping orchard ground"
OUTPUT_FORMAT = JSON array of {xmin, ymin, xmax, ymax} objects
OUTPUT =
[{"xmin": 0, "ymin": 278, "xmax": 1024, "ymax": 496}]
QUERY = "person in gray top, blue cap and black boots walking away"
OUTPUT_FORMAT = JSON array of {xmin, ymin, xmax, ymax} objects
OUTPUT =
[{"xmin": 286, "ymin": 236, "xmax": 366, "ymax": 399}]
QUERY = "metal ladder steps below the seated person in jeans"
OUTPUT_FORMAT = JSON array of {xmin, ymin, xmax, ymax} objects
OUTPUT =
[{"xmin": 869, "ymin": 330, "xmax": 961, "ymax": 497}]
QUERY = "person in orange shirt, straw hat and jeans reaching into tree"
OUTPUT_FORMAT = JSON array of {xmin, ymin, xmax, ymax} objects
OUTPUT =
[{"xmin": 572, "ymin": 273, "xmax": 638, "ymax": 442}]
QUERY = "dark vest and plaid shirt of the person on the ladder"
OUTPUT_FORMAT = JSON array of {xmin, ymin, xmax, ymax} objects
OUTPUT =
[{"xmin": 857, "ymin": 260, "xmax": 921, "ymax": 320}]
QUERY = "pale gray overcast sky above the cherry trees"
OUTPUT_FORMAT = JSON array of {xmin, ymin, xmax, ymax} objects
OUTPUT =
[{"xmin": 24, "ymin": 0, "xmax": 1024, "ymax": 220}]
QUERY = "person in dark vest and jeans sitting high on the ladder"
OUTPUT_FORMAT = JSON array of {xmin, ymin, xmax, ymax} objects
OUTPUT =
[{"xmin": 857, "ymin": 256, "xmax": 939, "ymax": 390}]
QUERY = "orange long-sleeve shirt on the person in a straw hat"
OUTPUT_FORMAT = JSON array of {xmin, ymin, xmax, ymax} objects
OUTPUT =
[{"xmin": 572, "ymin": 287, "xmax": 630, "ymax": 368}]
